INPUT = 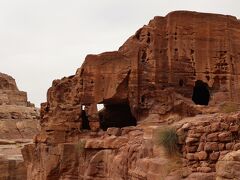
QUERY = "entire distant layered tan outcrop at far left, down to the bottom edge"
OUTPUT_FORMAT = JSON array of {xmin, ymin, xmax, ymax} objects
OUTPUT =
[{"xmin": 0, "ymin": 73, "xmax": 39, "ymax": 180}]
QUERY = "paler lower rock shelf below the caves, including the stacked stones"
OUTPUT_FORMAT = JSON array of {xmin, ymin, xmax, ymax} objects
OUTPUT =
[{"xmin": 23, "ymin": 112, "xmax": 240, "ymax": 180}]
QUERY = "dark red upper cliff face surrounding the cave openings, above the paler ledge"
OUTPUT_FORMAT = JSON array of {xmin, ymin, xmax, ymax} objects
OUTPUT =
[{"xmin": 41, "ymin": 11, "xmax": 240, "ymax": 134}]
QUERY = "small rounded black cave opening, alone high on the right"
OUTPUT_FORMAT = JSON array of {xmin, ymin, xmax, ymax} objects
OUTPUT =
[{"xmin": 192, "ymin": 80, "xmax": 210, "ymax": 105}]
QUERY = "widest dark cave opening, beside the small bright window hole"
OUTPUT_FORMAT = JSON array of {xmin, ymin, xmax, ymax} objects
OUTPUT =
[{"xmin": 99, "ymin": 103, "xmax": 137, "ymax": 131}]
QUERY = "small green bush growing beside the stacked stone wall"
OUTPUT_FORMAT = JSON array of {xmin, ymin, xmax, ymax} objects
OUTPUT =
[{"xmin": 156, "ymin": 127, "xmax": 178, "ymax": 155}]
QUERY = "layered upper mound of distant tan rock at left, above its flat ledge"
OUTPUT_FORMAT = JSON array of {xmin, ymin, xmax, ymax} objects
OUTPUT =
[{"xmin": 0, "ymin": 73, "xmax": 39, "ymax": 140}]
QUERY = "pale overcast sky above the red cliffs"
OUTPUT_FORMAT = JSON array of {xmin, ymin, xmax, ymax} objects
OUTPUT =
[{"xmin": 0, "ymin": 0, "xmax": 240, "ymax": 107}]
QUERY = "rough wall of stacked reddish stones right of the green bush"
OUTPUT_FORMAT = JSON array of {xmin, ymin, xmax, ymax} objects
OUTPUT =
[{"xmin": 177, "ymin": 114, "xmax": 240, "ymax": 173}]
